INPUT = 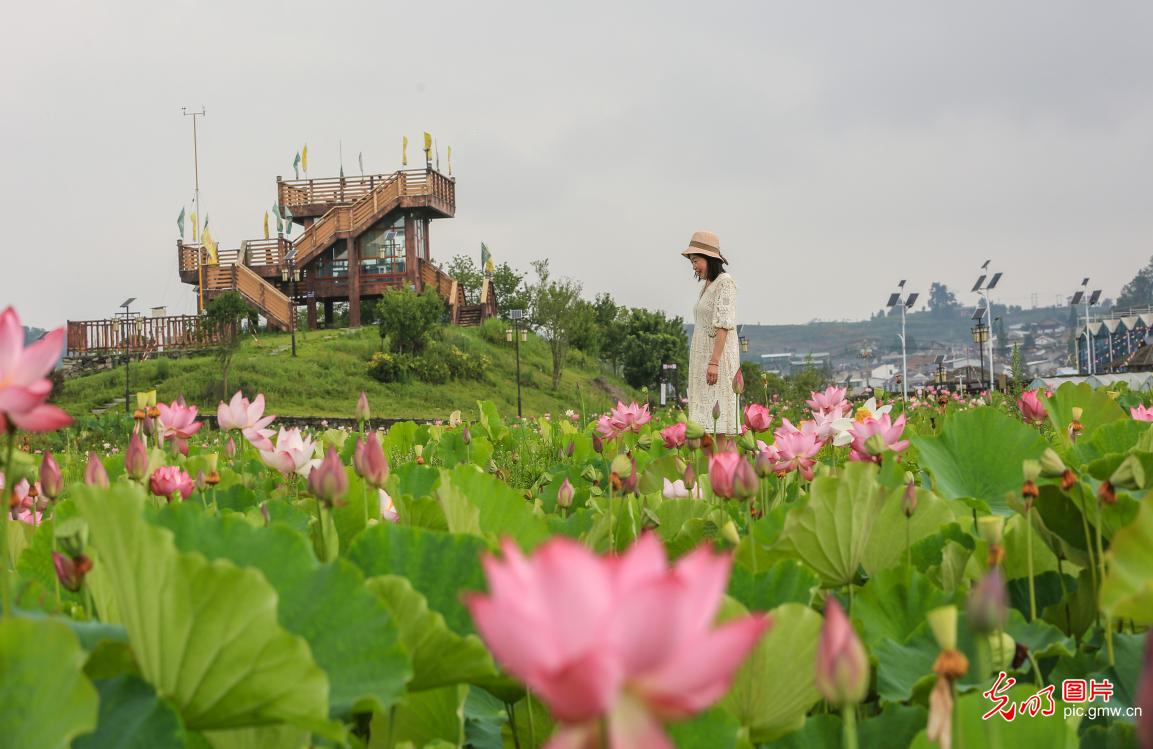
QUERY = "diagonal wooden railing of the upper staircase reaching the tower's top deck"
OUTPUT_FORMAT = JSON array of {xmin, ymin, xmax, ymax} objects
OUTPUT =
[{"xmin": 288, "ymin": 169, "xmax": 457, "ymax": 266}]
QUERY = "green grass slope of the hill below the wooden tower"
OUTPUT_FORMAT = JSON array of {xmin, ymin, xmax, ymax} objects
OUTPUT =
[{"xmin": 56, "ymin": 327, "xmax": 636, "ymax": 418}]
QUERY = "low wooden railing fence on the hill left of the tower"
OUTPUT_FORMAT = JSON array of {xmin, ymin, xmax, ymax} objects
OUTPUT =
[{"xmin": 65, "ymin": 315, "xmax": 221, "ymax": 357}]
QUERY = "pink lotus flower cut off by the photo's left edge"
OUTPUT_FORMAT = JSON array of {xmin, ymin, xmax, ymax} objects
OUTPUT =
[{"xmin": 0, "ymin": 307, "xmax": 73, "ymax": 432}]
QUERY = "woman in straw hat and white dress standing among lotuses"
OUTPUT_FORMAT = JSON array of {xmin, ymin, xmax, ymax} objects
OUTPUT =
[{"xmin": 681, "ymin": 232, "xmax": 740, "ymax": 434}]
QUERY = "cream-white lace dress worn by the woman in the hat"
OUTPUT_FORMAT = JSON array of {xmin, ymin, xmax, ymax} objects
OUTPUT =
[{"xmin": 688, "ymin": 273, "xmax": 740, "ymax": 434}]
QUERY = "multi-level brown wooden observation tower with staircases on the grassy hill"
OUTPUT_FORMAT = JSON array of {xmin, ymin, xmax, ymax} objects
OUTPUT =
[{"xmin": 176, "ymin": 166, "xmax": 497, "ymax": 330}]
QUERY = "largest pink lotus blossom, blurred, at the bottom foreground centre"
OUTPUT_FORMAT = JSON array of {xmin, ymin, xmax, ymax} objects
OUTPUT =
[{"xmin": 465, "ymin": 534, "xmax": 769, "ymax": 749}]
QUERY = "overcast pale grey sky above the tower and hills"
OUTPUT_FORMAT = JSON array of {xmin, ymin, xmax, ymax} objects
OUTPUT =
[{"xmin": 0, "ymin": 0, "xmax": 1153, "ymax": 327}]
